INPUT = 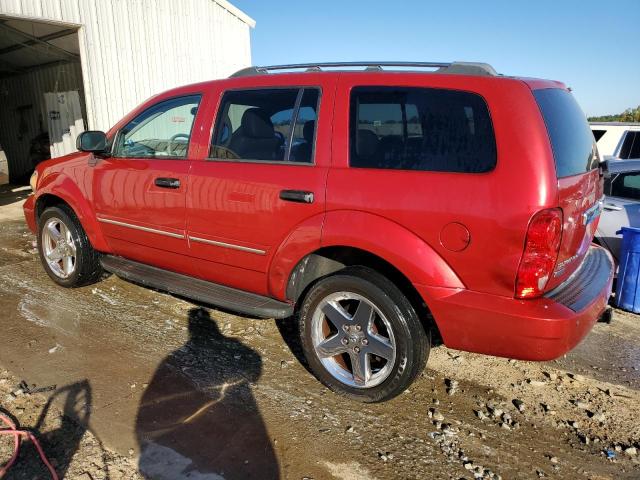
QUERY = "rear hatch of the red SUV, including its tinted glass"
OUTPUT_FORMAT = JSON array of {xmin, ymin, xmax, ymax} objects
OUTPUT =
[{"xmin": 533, "ymin": 88, "xmax": 603, "ymax": 290}]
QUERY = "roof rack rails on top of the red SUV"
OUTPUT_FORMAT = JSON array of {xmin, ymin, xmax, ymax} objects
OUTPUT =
[{"xmin": 230, "ymin": 62, "xmax": 498, "ymax": 78}]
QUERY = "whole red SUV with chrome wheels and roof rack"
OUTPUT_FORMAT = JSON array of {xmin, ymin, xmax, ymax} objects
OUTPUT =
[{"xmin": 24, "ymin": 62, "xmax": 613, "ymax": 402}]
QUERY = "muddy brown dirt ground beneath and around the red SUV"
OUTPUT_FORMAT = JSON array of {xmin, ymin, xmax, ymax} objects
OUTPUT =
[{"xmin": 0, "ymin": 183, "xmax": 640, "ymax": 480}]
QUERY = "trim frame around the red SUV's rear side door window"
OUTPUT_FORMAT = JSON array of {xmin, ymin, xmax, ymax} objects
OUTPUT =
[{"xmin": 205, "ymin": 85, "xmax": 322, "ymax": 167}]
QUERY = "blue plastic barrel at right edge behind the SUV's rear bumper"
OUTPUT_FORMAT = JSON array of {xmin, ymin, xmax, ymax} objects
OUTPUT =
[{"xmin": 616, "ymin": 227, "xmax": 640, "ymax": 313}]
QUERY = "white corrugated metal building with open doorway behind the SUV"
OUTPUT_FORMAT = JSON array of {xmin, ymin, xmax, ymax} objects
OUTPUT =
[{"xmin": 0, "ymin": 0, "xmax": 255, "ymax": 179}]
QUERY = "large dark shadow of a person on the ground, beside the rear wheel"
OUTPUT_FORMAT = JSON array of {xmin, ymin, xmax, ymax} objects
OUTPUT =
[{"xmin": 136, "ymin": 308, "xmax": 279, "ymax": 480}]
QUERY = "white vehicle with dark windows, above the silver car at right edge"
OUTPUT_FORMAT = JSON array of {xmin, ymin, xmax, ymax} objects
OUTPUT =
[{"xmin": 589, "ymin": 122, "xmax": 640, "ymax": 160}]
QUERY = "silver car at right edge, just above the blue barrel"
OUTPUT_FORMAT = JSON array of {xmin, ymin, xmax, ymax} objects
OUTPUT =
[{"xmin": 595, "ymin": 158, "xmax": 640, "ymax": 263}]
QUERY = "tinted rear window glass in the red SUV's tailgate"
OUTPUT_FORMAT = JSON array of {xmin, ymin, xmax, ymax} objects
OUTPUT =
[{"xmin": 533, "ymin": 88, "xmax": 598, "ymax": 178}]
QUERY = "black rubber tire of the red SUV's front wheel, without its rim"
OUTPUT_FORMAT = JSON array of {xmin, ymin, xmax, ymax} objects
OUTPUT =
[{"xmin": 37, "ymin": 205, "xmax": 104, "ymax": 288}]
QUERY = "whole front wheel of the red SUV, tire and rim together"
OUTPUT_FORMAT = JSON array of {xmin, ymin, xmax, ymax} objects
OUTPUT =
[{"xmin": 38, "ymin": 205, "xmax": 103, "ymax": 287}]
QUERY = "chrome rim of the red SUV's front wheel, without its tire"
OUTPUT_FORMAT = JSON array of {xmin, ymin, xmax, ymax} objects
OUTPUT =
[{"xmin": 41, "ymin": 217, "xmax": 76, "ymax": 278}]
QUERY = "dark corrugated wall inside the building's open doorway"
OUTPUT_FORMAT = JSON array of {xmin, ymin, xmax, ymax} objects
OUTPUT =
[{"xmin": 0, "ymin": 63, "xmax": 83, "ymax": 177}]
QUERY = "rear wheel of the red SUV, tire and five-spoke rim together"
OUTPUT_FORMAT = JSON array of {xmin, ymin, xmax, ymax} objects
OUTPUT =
[{"xmin": 299, "ymin": 267, "xmax": 430, "ymax": 402}]
